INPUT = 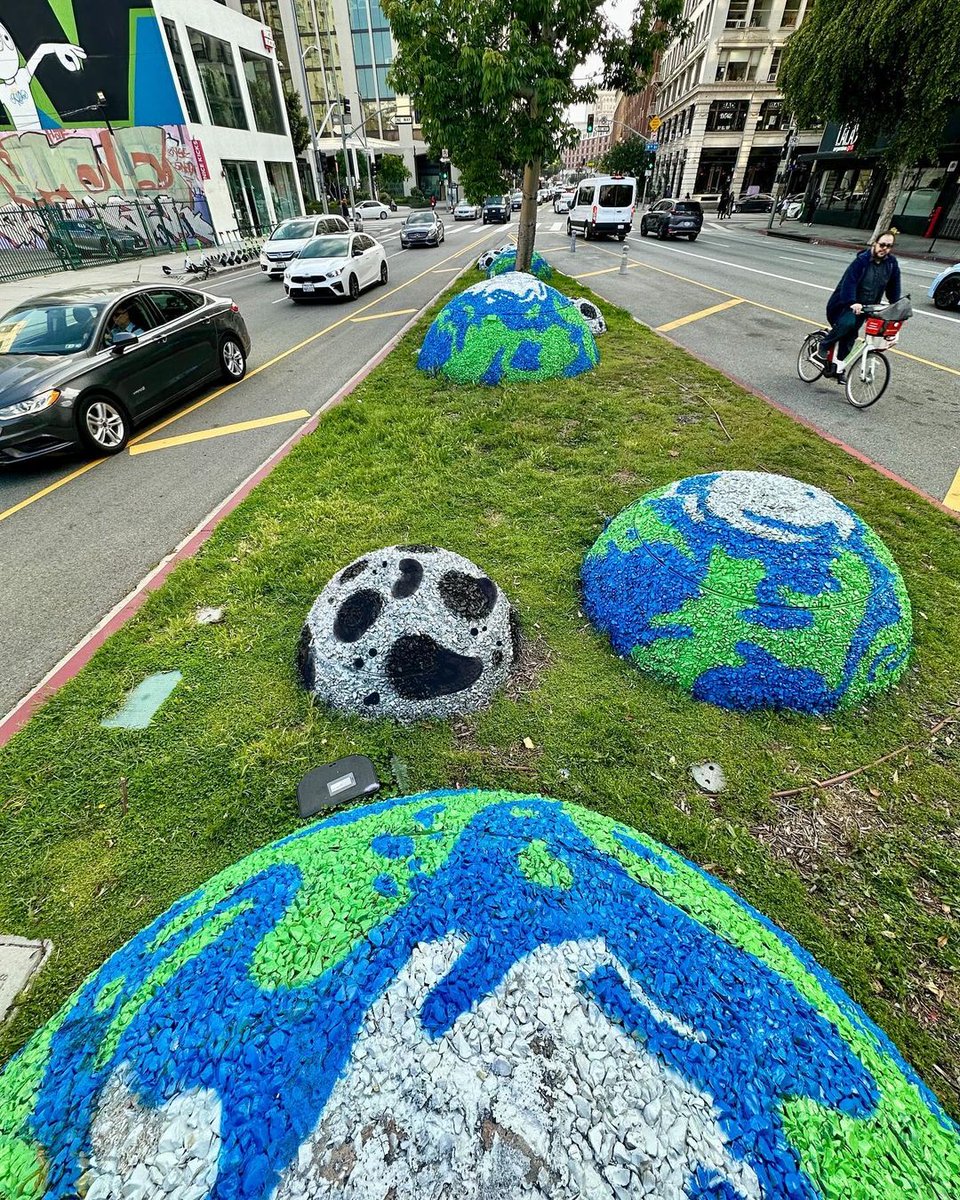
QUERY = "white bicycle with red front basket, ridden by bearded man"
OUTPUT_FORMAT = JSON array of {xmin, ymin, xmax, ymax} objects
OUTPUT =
[{"xmin": 797, "ymin": 296, "xmax": 913, "ymax": 408}]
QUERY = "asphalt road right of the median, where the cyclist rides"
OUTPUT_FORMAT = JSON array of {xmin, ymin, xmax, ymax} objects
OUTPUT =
[{"xmin": 538, "ymin": 217, "xmax": 960, "ymax": 509}]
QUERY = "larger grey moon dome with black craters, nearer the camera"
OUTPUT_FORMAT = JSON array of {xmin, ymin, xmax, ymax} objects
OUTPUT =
[{"xmin": 298, "ymin": 545, "xmax": 518, "ymax": 721}]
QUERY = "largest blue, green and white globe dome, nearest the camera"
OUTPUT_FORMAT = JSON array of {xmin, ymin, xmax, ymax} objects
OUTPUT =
[{"xmin": 0, "ymin": 791, "xmax": 960, "ymax": 1200}]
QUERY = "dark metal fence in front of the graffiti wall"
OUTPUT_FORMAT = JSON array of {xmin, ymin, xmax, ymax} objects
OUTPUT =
[{"xmin": 0, "ymin": 197, "xmax": 263, "ymax": 288}]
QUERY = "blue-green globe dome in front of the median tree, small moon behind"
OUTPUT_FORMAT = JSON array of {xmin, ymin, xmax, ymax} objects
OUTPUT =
[{"xmin": 416, "ymin": 271, "xmax": 599, "ymax": 384}]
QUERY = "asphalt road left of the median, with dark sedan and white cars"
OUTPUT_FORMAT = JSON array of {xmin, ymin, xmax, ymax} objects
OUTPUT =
[{"xmin": 0, "ymin": 217, "xmax": 516, "ymax": 714}]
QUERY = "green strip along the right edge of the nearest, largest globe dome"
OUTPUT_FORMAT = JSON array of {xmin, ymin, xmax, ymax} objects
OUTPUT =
[{"xmin": 563, "ymin": 804, "xmax": 960, "ymax": 1200}]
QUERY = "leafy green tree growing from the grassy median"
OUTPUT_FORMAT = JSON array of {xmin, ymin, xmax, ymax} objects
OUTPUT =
[{"xmin": 382, "ymin": 0, "xmax": 685, "ymax": 270}]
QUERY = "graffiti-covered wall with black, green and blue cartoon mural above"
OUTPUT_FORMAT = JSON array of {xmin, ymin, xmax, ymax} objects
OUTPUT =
[{"xmin": 0, "ymin": 0, "xmax": 211, "ymax": 245}]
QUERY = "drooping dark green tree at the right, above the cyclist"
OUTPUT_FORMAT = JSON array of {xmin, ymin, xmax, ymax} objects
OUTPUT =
[{"xmin": 779, "ymin": 0, "xmax": 960, "ymax": 235}]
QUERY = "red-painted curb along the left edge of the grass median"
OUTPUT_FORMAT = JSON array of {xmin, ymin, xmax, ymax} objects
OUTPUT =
[{"xmin": 0, "ymin": 258, "xmax": 474, "ymax": 746}]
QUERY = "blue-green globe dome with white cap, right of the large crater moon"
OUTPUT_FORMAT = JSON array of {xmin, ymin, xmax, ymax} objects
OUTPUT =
[{"xmin": 581, "ymin": 470, "xmax": 913, "ymax": 713}]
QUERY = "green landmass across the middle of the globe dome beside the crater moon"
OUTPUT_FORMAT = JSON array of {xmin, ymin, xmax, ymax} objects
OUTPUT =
[{"xmin": 630, "ymin": 546, "xmax": 910, "ymax": 708}]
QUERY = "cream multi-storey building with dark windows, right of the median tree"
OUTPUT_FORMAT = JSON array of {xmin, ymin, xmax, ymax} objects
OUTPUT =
[{"xmin": 654, "ymin": 0, "xmax": 820, "ymax": 197}]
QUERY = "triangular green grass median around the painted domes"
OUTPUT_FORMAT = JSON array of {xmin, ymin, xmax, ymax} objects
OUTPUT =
[{"xmin": 0, "ymin": 262, "xmax": 960, "ymax": 1116}]
